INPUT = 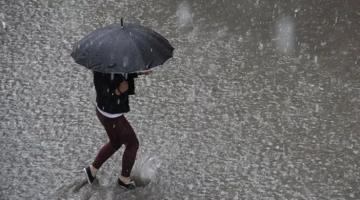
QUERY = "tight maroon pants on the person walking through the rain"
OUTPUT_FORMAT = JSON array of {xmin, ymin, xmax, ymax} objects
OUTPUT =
[{"xmin": 92, "ymin": 108, "xmax": 139, "ymax": 177}]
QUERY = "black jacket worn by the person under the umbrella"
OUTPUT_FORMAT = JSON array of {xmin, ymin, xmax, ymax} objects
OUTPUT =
[{"xmin": 93, "ymin": 72, "xmax": 137, "ymax": 114}]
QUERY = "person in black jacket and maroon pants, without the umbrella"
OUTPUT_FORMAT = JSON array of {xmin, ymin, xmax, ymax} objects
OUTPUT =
[{"xmin": 84, "ymin": 70, "xmax": 152, "ymax": 189}]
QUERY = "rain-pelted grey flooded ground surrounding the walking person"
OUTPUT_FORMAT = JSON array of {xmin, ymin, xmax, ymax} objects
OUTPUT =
[{"xmin": 0, "ymin": 0, "xmax": 360, "ymax": 200}]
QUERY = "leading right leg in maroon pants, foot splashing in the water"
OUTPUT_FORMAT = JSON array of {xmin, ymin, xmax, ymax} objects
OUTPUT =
[{"xmin": 117, "ymin": 116, "xmax": 139, "ymax": 183}]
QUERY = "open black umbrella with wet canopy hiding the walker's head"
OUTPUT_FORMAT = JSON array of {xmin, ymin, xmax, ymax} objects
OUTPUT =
[{"xmin": 71, "ymin": 18, "xmax": 174, "ymax": 73}]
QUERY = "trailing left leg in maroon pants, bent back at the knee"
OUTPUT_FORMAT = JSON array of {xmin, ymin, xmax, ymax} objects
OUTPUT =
[{"xmin": 90, "ymin": 109, "xmax": 121, "ymax": 176}]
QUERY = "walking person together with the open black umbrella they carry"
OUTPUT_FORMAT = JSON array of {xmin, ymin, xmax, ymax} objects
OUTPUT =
[{"xmin": 70, "ymin": 18, "xmax": 175, "ymax": 189}]
